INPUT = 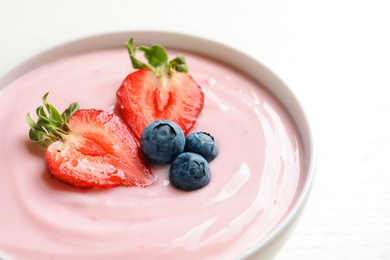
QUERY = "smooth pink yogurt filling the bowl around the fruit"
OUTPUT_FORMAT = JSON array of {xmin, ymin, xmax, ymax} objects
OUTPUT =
[{"xmin": 0, "ymin": 48, "xmax": 305, "ymax": 259}]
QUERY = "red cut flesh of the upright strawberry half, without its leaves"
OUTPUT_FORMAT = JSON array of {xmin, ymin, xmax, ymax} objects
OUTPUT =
[{"xmin": 117, "ymin": 69, "xmax": 204, "ymax": 138}]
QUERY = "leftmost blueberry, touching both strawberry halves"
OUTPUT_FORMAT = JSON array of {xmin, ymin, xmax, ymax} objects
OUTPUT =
[{"xmin": 140, "ymin": 120, "xmax": 185, "ymax": 164}]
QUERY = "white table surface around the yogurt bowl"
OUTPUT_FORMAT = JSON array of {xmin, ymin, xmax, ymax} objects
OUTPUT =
[{"xmin": 0, "ymin": 0, "xmax": 390, "ymax": 260}]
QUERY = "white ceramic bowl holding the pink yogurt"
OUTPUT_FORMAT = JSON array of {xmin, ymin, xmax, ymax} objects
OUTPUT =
[{"xmin": 0, "ymin": 31, "xmax": 315, "ymax": 259}]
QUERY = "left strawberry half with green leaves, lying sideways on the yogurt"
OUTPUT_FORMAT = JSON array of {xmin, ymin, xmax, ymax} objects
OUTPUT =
[{"xmin": 26, "ymin": 94, "xmax": 155, "ymax": 188}]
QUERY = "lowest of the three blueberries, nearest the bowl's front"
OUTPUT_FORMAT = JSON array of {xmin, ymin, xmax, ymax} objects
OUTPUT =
[{"xmin": 169, "ymin": 153, "xmax": 211, "ymax": 191}]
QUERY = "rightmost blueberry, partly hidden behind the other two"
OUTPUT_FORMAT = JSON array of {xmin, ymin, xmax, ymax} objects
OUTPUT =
[{"xmin": 184, "ymin": 132, "xmax": 219, "ymax": 162}]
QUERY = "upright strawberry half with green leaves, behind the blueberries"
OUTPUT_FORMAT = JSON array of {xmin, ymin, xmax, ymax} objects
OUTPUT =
[{"xmin": 117, "ymin": 38, "xmax": 204, "ymax": 138}]
